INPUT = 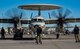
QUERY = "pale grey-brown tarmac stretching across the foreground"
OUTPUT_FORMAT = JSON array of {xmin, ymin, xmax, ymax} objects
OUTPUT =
[{"xmin": 0, "ymin": 35, "xmax": 80, "ymax": 49}]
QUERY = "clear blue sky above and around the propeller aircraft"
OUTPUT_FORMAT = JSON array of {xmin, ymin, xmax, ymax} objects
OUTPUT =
[{"xmin": 0, "ymin": 0, "xmax": 80, "ymax": 28}]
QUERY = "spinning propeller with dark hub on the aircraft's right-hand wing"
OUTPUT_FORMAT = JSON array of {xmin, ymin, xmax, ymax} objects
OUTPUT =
[{"xmin": 52, "ymin": 8, "xmax": 71, "ymax": 30}]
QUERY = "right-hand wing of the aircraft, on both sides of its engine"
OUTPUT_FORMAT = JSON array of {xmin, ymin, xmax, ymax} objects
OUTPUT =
[{"xmin": 45, "ymin": 18, "xmax": 80, "ymax": 24}]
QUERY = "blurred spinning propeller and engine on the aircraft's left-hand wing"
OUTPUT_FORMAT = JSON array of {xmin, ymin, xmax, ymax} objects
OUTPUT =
[{"xmin": 5, "ymin": 8, "xmax": 24, "ymax": 28}]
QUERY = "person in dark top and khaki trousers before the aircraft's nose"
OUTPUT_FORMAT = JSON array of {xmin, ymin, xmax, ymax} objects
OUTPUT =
[{"xmin": 35, "ymin": 25, "xmax": 42, "ymax": 44}]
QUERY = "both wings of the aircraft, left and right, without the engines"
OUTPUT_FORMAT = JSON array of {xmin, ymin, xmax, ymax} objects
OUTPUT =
[{"xmin": 0, "ymin": 18, "xmax": 80, "ymax": 24}]
